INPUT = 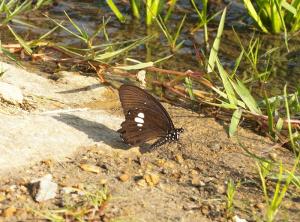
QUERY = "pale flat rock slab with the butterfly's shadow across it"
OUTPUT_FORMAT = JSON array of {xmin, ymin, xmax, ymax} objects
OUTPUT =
[{"xmin": 0, "ymin": 110, "xmax": 124, "ymax": 174}]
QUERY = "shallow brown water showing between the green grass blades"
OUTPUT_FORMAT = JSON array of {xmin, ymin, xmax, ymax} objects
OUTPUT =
[{"xmin": 1, "ymin": 0, "xmax": 300, "ymax": 96}]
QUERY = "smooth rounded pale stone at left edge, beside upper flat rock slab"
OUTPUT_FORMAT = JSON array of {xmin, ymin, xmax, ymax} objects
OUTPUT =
[{"xmin": 0, "ymin": 82, "xmax": 24, "ymax": 104}]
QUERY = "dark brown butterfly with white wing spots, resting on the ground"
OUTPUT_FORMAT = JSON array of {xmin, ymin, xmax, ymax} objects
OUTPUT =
[{"xmin": 118, "ymin": 85, "xmax": 183, "ymax": 150}]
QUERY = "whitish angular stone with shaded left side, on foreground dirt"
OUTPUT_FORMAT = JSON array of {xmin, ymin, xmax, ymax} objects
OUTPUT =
[{"xmin": 30, "ymin": 174, "xmax": 58, "ymax": 202}]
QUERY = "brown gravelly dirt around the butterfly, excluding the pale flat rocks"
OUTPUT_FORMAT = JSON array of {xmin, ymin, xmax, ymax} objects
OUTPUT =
[{"xmin": 0, "ymin": 61, "xmax": 300, "ymax": 221}]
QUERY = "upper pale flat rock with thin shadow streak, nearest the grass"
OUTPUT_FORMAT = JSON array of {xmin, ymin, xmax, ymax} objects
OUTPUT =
[{"xmin": 0, "ymin": 62, "xmax": 106, "ymax": 104}]
